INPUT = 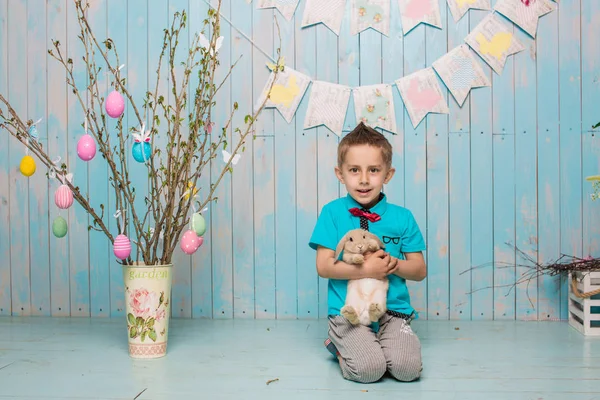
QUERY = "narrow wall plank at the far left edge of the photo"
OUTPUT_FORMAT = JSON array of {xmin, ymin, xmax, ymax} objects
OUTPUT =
[{"xmin": 0, "ymin": 2, "xmax": 9, "ymax": 316}]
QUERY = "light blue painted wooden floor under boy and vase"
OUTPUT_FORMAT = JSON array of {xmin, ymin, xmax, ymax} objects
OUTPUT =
[{"xmin": 0, "ymin": 317, "xmax": 600, "ymax": 400}]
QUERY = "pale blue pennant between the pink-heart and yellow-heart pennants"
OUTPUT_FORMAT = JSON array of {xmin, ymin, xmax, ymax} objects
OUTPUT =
[{"xmin": 433, "ymin": 44, "xmax": 491, "ymax": 107}]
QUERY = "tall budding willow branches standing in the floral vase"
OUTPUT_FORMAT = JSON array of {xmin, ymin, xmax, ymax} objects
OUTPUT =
[{"xmin": 0, "ymin": 0, "xmax": 281, "ymax": 264}]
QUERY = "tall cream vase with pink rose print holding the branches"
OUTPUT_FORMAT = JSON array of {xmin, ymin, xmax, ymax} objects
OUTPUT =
[{"xmin": 123, "ymin": 263, "xmax": 173, "ymax": 358}]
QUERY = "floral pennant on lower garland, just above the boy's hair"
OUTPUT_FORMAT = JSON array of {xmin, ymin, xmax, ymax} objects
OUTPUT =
[{"xmin": 353, "ymin": 84, "xmax": 397, "ymax": 133}]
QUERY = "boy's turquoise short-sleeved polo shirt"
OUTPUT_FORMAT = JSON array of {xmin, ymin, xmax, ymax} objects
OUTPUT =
[{"xmin": 309, "ymin": 195, "xmax": 425, "ymax": 315}]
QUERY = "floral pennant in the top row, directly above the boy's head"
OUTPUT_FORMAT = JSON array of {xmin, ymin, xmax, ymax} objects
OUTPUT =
[{"xmin": 350, "ymin": 0, "xmax": 390, "ymax": 36}]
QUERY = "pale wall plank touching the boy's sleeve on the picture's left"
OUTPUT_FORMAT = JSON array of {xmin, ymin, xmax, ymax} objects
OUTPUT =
[{"xmin": 295, "ymin": 12, "xmax": 323, "ymax": 318}]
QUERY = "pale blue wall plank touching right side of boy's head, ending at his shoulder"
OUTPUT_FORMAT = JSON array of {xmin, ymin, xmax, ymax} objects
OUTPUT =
[{"xmin": 381, "ymin": 1, "xmax": 405, "ymax": 206}]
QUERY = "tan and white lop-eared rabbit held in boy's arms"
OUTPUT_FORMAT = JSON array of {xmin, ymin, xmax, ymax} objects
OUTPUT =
[{"xmin": 335, "ymin": 229, "xmax": 389, "ymax": 326}]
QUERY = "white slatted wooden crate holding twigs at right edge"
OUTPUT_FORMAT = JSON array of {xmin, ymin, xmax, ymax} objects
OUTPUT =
[{"xmin": 569, "ymin": 271, "xmax": 600, "ymax": 336}]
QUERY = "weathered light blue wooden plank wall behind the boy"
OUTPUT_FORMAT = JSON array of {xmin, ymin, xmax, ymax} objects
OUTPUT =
[{"xmin": 0, "ymin": 0, "xmax": 600, "ymax": 320}]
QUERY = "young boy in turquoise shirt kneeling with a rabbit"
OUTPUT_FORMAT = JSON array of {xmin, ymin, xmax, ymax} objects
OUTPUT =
[{"xmin": 309, "ymin": 122, "xmax": 427, "ymax": 383}]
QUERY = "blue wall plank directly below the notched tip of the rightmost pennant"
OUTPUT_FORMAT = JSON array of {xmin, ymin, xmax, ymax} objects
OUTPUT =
[{"xmin": 514, "ymin": 24, "xmax": 538, "ymax": 320}]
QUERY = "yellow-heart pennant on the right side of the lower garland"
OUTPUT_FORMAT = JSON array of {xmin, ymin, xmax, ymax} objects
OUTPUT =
[{"xmin": 465, "ymin": 13, "xmax": 525, "ymax": 75}]
